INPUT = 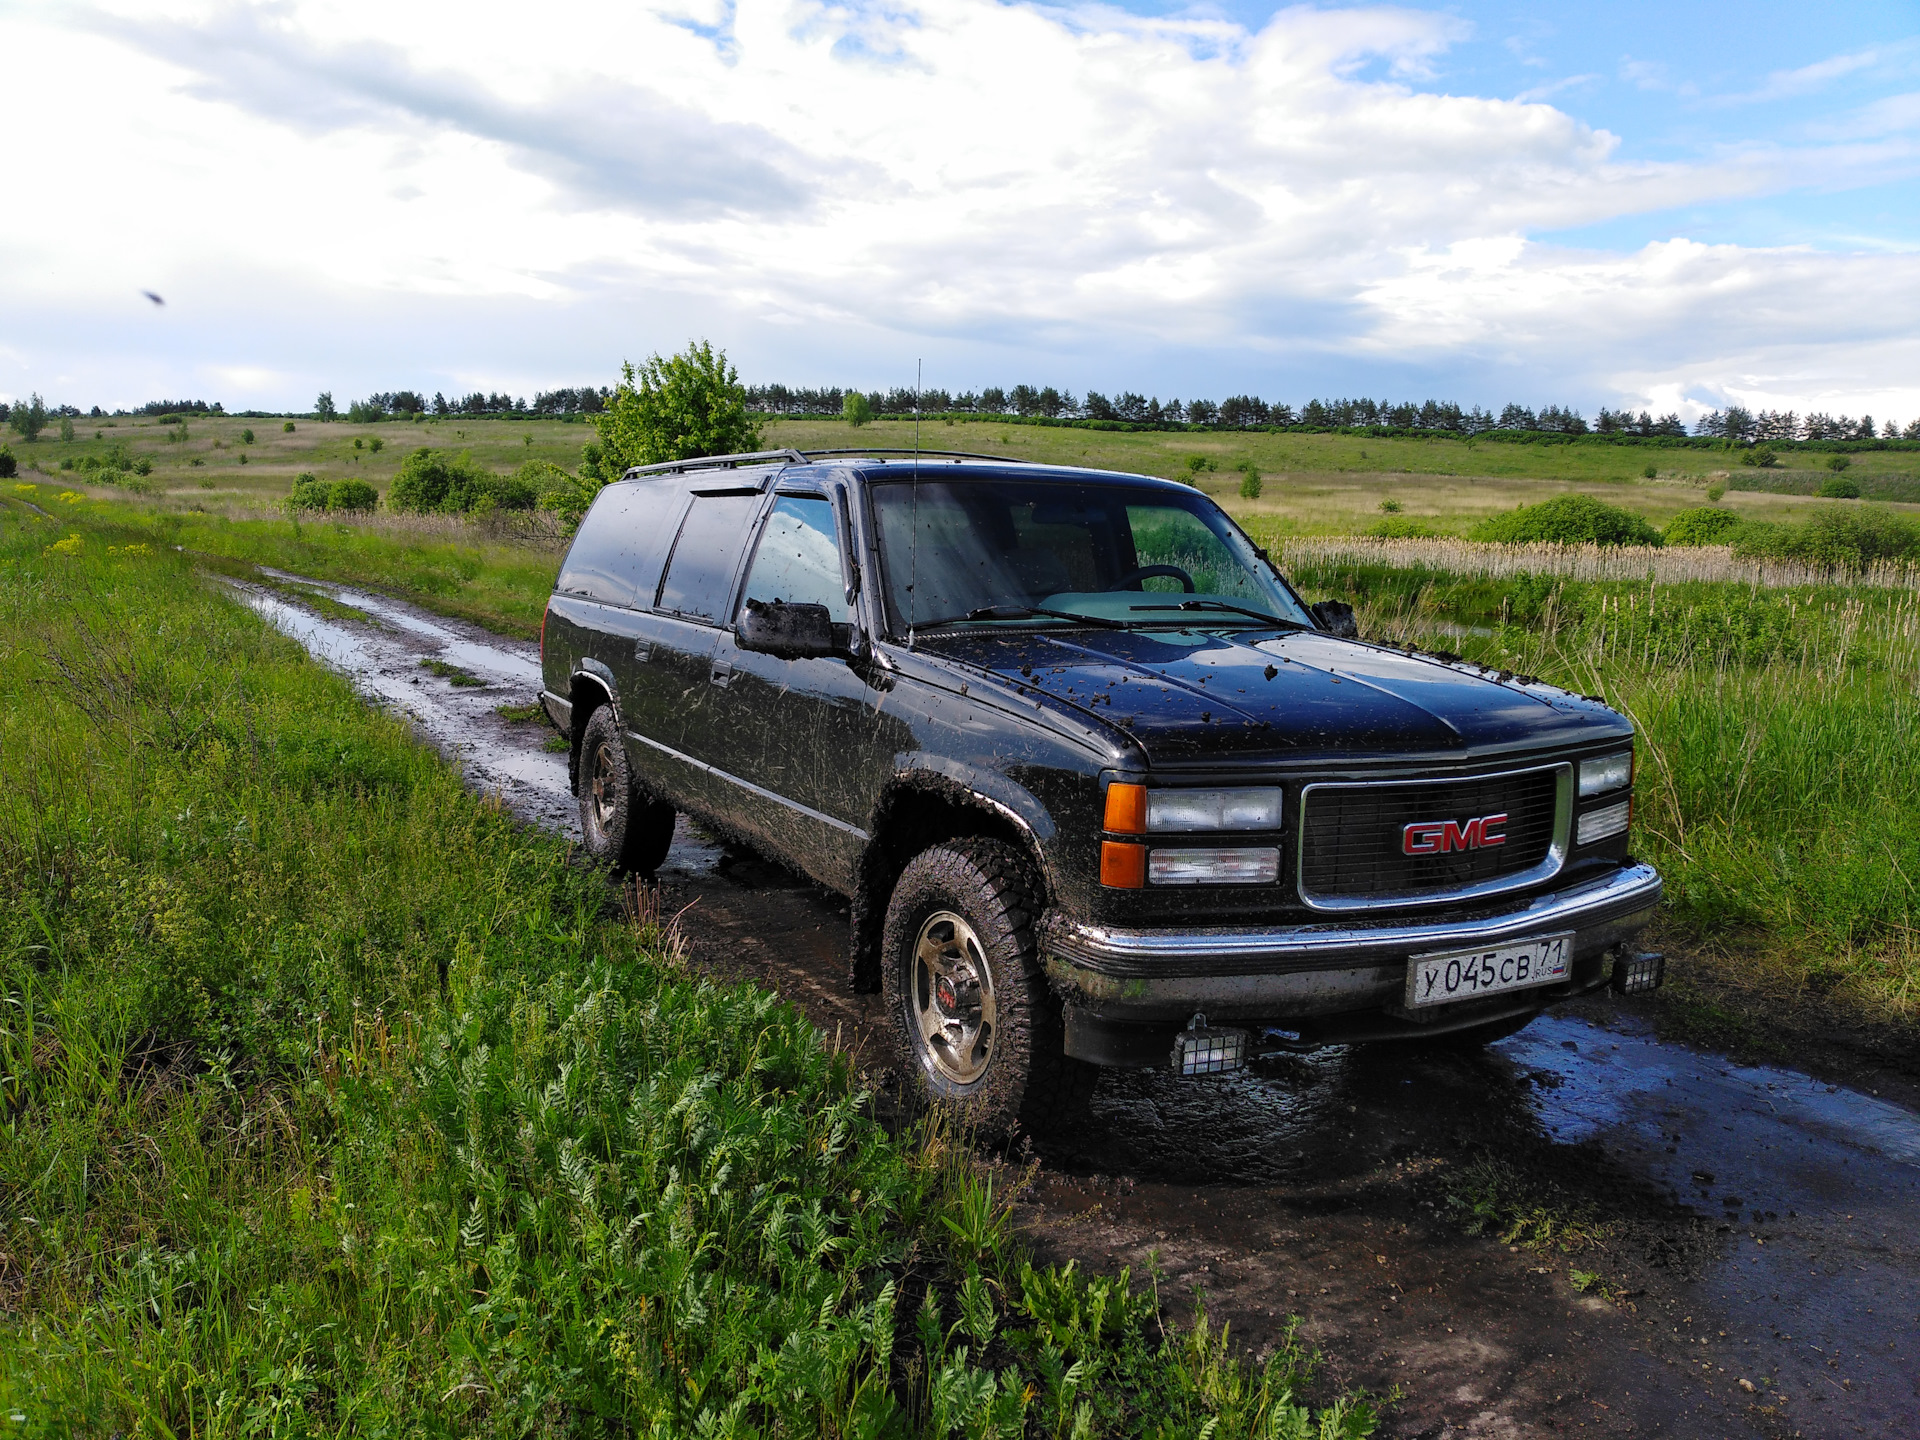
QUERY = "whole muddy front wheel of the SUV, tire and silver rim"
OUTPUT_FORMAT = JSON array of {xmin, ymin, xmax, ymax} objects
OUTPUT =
[{"xmin": 881, "ymin": 839, "xmax": 1092, "ymax": 1142}]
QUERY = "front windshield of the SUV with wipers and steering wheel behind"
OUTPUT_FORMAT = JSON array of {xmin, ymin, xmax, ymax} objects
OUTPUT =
[{"xmin": 872, "ymin": 476, "xmax": 1313, "ymax": 634}]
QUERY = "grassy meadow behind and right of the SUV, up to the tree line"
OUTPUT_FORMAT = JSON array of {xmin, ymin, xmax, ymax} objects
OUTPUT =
[{"xmin": 18, "ymin": 410, "xmax": 1920, "ymax": 1044}]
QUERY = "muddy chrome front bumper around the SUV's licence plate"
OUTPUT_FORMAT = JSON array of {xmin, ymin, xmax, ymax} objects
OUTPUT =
[{"xmin": 1041, "ymin": 864, "xmax": 1661, "ymax": 1021}]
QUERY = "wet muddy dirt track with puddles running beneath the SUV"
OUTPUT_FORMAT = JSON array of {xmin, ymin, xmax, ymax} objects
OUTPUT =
[{"xmin": 236, "ymin": 576, "xmax": 1920, "ymax": 1440}]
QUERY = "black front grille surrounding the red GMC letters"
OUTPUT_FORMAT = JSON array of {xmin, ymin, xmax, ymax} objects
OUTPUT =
[{"xmin": 1300, "ymin": 766, "xmax": 1571, "ymax": 908}]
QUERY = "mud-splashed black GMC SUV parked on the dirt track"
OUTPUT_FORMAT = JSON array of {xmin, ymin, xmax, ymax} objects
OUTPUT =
[{"xmin": 541, "ymin": 451, "xmax": 1661, "ymax": 1133}]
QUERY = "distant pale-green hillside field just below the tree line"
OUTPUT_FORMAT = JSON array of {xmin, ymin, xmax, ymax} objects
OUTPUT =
[{"xmin": 15, "ymin": 419, "xmax": 1920, "ymax": 536}]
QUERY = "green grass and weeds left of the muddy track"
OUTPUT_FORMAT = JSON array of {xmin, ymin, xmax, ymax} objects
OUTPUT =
[{"xmin": 0, "ymin": 495, "xmax": 1373, "ymax": 1436}]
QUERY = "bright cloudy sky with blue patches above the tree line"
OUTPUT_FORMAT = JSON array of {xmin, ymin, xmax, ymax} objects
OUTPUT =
[{"xmin": 0, "ymin": 0, "xmax": 1920, "ymax": 420}]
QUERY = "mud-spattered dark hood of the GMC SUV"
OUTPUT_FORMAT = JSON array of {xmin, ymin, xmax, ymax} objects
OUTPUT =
[{"xmin": 920, "ymin": 630, "xmax": 1630, "ymax": 762}]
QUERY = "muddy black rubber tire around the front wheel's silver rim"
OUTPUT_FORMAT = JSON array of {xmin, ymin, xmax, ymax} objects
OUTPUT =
[{"xmin": 879, "ymin": 839, "xmax": 1098, "ymax": 1142}]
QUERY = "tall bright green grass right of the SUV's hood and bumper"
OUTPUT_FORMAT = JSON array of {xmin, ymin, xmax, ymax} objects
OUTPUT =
[{"xmin": 1296, "ymin": 545, "xmax": 1920, "ymax": 1020}]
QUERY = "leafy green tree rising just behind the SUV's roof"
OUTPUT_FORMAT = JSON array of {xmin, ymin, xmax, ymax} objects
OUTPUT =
[{"xmin": 593, "ymin": 340, "xmax": 760, "ymax": 474}]
